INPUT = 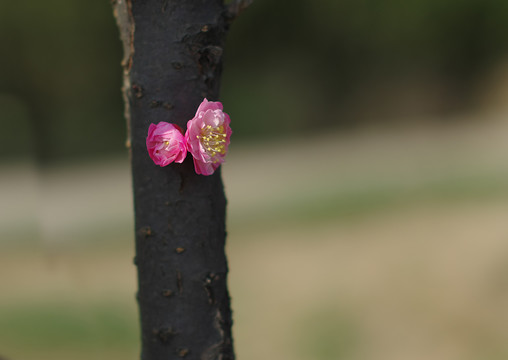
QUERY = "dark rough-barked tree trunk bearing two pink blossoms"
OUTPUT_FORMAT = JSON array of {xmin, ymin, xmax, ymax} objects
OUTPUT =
[{"xmin": 113, "ymin": 0, "xmax": 245, "ymax": 360}]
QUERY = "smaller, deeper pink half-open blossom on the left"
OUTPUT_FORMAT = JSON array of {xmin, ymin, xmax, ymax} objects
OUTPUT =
[{"xmin": 146, "ymin": 121, "xmax": 187, "ymax": 166}]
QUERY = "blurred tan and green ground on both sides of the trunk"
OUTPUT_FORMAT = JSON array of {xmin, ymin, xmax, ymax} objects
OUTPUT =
[{"xmin": 0, "ymin": 115, "xmax": 508, "ymax": 360}]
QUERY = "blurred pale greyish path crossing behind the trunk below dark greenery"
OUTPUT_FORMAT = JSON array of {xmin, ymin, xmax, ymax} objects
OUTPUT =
[{"xmin": 0, "ymin": 116, "xmax": 508, "ymax": 242}]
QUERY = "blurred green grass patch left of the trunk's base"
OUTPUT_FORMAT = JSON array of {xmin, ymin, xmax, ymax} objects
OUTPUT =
[{"xmin": 0, "ymin": 299, "xmax": 139, "ymax": 352}]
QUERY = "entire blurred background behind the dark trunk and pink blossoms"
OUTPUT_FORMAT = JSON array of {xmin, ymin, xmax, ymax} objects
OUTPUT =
[{"xmin": 0, "ymin": 0, "xmax": 508, "ymax": 360}]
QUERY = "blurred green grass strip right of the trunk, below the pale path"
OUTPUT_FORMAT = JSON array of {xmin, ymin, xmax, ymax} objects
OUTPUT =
[{"xmin": 232, "ymin": 170, "xmax": 508, "ymax": 229}]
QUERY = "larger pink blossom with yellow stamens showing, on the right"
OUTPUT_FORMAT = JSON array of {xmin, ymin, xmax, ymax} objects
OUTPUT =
[{"xmin": 185, "ymin": 99, "xmax": 232, "ymax": 175}]
